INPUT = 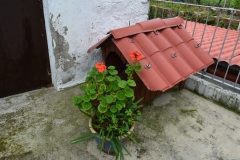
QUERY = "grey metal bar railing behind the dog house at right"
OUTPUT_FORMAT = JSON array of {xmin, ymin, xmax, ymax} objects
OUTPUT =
[{"xmin": 149, "ymin": 0, "xmax": 240, "ymax": 92}]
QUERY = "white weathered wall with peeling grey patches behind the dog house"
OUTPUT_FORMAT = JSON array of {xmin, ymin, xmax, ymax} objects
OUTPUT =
[{"xmin": 43, "ymin": 0, "xmax": 149, "ymax": 90}]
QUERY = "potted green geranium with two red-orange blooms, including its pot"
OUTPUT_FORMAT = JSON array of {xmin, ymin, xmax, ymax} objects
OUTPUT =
[{"xmin": 72, "ymin": 51, "xmax": 147, "ymax": 159}]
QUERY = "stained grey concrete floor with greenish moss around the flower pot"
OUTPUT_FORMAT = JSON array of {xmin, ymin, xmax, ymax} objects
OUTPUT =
[{"xmin": 0, "ymin": 86, "xmax": 240, "ymax": 160}]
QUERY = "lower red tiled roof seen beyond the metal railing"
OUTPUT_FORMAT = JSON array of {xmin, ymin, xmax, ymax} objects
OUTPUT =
[{"xmin": 186, "ymin": 21, "xmax": 240, "ymax": 67}]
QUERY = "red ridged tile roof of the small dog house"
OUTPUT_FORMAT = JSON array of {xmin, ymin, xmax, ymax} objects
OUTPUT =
[{"xmin": 88, "ymin": 17, "xmax": 213, "ymax": 91}]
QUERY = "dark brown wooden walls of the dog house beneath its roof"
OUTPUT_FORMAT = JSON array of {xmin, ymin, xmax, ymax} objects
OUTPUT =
[{"xmin": 101, "ymin": 42, "xmax": 161, "ymax": 104}]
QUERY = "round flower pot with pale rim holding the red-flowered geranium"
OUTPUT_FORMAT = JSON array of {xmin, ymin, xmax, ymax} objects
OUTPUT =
[{"xmin": 89, "ymin": 118, "xmax": 135, "ymax": 155}]
